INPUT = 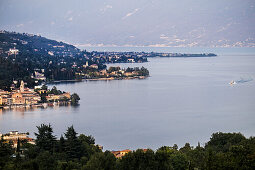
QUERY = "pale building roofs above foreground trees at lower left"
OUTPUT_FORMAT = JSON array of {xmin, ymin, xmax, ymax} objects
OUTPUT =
[{"xmin": 0, "ymin": 131, "xmax": 35, "ymax": 148}]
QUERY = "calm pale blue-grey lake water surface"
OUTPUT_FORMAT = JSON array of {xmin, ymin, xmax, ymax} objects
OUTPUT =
[{"xmin": 0, "ymin": 49, "xmax": 255, "ymax": 150}]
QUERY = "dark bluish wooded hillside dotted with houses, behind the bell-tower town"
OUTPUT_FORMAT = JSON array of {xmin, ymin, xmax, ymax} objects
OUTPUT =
[{"xmin": 0, "ymin": 31, "xmax": 105, "ymax": 89}]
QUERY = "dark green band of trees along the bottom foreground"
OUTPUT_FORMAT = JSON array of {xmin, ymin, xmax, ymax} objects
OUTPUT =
[{"xmin": 0, "ymin": 124, "xmax": 255, "ymax": 170}]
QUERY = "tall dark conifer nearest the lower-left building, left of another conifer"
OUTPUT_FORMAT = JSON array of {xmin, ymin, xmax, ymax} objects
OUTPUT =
[{"xmin": 35, "ymin": 124, "xmax": 56, "ymax": 153}]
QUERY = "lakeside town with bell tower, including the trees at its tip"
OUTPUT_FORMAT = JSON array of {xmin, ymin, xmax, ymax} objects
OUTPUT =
[{"xmin": 0, "ymin": 80, "xmax": 80, "ymax": 109}]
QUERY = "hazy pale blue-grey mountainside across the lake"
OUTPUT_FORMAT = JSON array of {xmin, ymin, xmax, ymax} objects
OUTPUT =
[{"xmin": 0, "ymin": 0, "xmax": 255, "ymax": 47}]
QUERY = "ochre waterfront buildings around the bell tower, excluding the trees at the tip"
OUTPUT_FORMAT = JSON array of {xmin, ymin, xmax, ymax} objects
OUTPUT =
[{"xmin": 0, "ymin": 81, "xmax": 71, "ymax": 107}]
